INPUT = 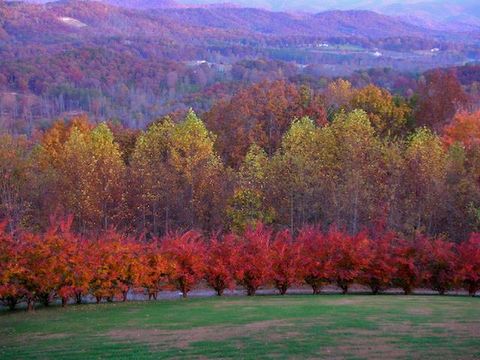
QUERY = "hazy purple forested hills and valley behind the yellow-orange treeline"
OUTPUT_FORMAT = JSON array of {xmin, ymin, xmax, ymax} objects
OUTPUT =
[{"xmin": 0, "ymin": 0, "xmax": 479, "ymax": 134}]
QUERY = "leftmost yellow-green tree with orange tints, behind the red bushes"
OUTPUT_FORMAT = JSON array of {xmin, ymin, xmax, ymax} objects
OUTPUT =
[{"xmin": 58, "ymin": 124, "xmax": 125, "ymax": 229}]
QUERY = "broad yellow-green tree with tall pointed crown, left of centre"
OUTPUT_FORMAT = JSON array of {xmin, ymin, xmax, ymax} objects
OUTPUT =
[{"xmin": 131, "ymin": 110, "xmax": 225, "ymax": 234}]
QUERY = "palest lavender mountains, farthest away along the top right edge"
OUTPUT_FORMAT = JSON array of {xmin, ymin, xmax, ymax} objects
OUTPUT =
[{"xmin": 12, "ymin": 0, "xmax": 480, "ymax": 34}]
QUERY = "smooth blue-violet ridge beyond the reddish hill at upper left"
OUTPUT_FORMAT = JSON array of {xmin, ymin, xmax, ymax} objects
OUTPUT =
[{"xmin": 146, "ymin": 8, "xmax": 433, "ymax": 38}]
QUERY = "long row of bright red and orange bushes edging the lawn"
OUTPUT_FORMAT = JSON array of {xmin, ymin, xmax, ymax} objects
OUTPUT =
[{"xmin": 0, "ymin": 221, "xmax": 480, "ymax": 309}]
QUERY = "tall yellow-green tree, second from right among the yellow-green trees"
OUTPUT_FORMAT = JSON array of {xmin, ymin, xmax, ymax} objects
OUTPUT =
[{"xmin": 324, "ymin": 110, "xmax": 385, "ymax": 233}]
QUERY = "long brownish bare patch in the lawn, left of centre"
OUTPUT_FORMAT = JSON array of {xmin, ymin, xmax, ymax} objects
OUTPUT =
[{"xmin": 107, "ymin": 320, "xmax": 299, "ymax": 348}]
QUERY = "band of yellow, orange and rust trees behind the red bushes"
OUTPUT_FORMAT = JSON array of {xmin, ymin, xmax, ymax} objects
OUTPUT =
[{"xmin": 0, "ymin": 73, "xmax": 480, "ymax": 241}]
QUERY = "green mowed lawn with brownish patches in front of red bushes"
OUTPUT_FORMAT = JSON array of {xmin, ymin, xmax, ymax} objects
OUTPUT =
[{"xmin": 0, "ymin": 295, "xmax": 480, "ymax": 359}]
